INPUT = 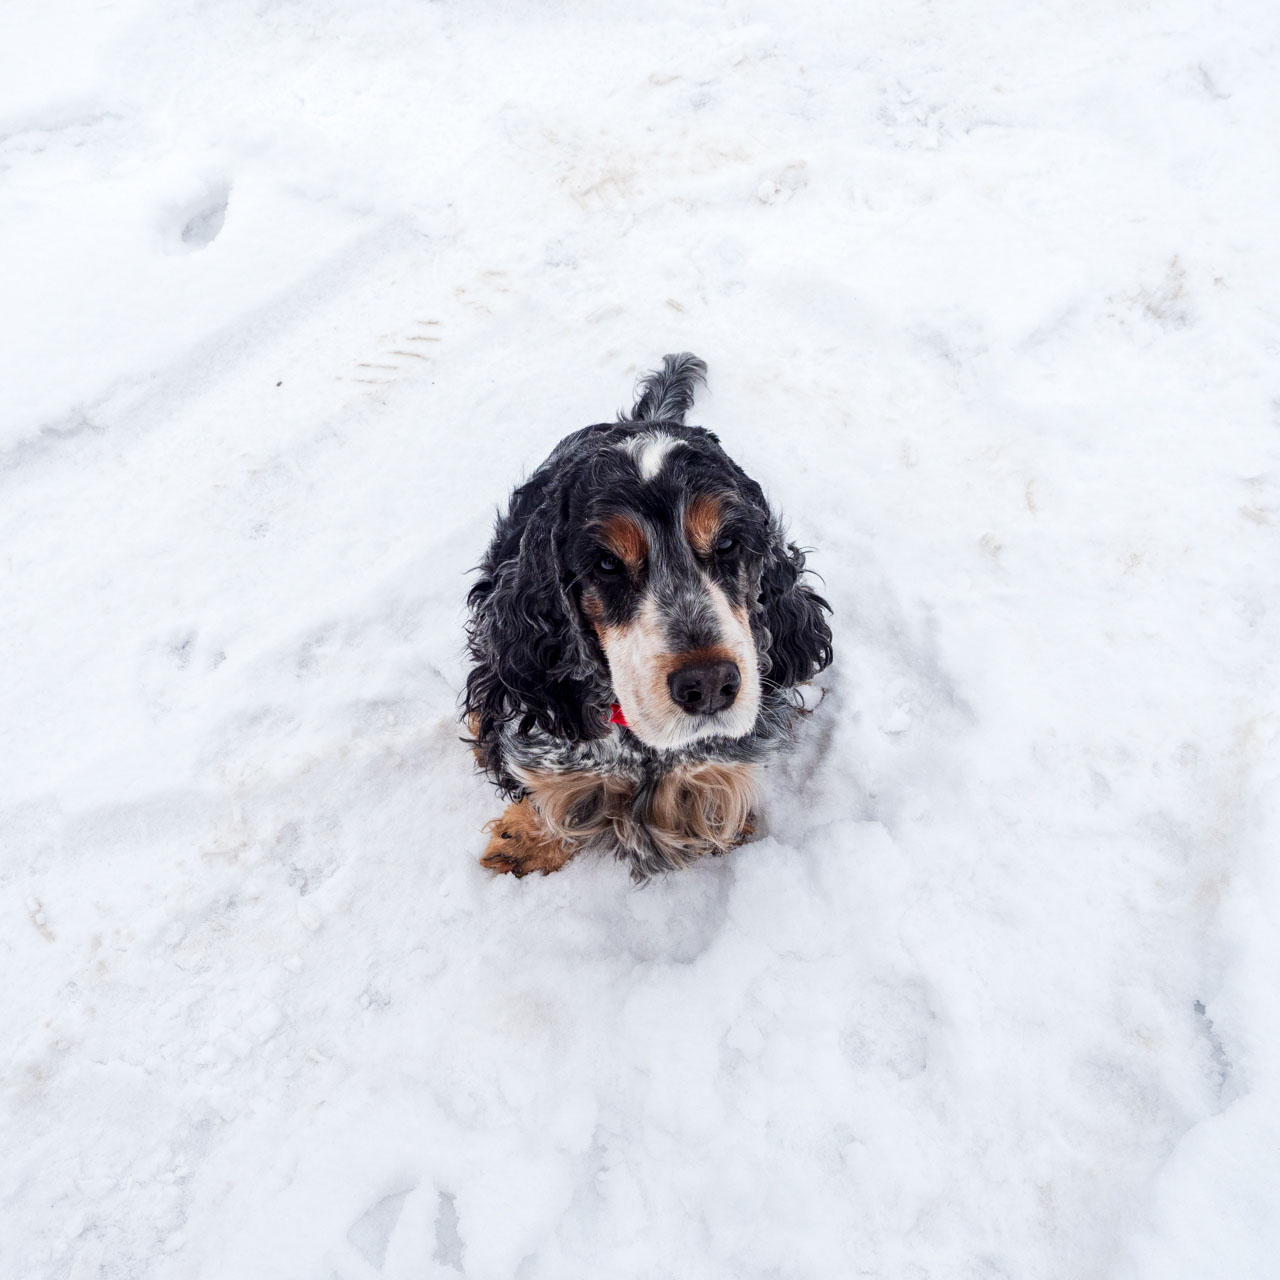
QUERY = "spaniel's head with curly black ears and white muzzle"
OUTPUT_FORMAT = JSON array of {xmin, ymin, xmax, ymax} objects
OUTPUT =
[{"xmin": 467, "ymin": 421, "xmax": 831, "ymax": 750}]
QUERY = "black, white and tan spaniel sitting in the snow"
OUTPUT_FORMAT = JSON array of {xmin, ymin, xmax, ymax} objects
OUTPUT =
[{"xmin": 462, "ymin": 352, "xmax": 832, "ymax": 882}]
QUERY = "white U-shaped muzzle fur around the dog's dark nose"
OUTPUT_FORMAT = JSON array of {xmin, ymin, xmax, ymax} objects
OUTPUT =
[{"xmin": 602, "ymin": 579, "xmax": 760, "ymax": 751}]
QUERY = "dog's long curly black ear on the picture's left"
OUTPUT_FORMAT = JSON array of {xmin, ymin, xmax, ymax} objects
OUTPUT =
[{"xmin": 463, "ymin": 481, "xmax": 608, "ymax": 767}]
